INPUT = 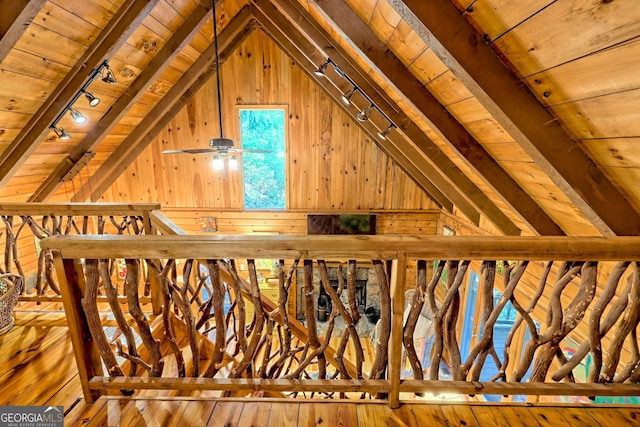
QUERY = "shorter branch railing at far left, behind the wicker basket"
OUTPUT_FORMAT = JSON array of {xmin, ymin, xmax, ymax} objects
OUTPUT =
[{"xmin": 0, "ymin": 203, "xmax": 160, "ymax": 312}]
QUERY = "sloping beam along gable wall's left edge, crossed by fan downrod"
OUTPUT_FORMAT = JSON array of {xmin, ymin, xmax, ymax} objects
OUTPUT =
[{"xmin": 71, "ymin": 7, "xmax": 256, "ymax": 201}]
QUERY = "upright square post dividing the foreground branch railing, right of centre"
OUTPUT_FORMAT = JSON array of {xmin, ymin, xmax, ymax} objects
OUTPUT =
[{"xmin": 388, "ymin": 252, "xmax": 407, "ymax": 408}]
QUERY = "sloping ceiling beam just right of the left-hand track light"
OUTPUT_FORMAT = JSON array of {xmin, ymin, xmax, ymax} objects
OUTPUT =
[{"xmin": 29, "ymin": 5, "xmax": 211, "ymax": 202}]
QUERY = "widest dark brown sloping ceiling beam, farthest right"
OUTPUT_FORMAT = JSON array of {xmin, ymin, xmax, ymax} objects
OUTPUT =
[{"xmin": 384, "ymin": 0, "xmax": 640, "ymax": 235}]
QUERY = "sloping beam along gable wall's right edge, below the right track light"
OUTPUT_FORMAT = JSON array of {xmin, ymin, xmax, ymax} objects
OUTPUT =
[{"xmin": 254, "ymin": 9, "xmax": 456, "ymax": 213}]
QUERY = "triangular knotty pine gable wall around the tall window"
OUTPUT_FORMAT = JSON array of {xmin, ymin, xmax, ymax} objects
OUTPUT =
[{"xmin": 103, "ymin": 30, "xmax": 437, "ymax": 211}]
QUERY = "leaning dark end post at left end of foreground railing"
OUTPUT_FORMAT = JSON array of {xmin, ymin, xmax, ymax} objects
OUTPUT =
[{"xmin": 53, "ymin": 254, "xmax": 103, "ymax": 403}]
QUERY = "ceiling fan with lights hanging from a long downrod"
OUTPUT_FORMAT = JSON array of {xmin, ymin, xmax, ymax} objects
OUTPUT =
[{"xmin": 162, "ymin": 0, "xmax": 270, "ymax": 160}]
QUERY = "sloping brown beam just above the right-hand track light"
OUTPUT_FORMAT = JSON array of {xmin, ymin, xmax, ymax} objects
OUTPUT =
[{"xmin": 254, "ymin": 0, "xmax": 520, "ymax": 235}]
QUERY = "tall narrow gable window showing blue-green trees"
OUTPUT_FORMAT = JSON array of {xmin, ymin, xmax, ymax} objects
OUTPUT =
[{"xmin": 240, "ymin": 108, "xmax": 286, "ymax": 209}]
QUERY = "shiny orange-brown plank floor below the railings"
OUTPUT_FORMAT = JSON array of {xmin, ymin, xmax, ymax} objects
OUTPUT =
[{"xmin": 0, "ymin": 306, "xmax": 640, "ymax": 427}]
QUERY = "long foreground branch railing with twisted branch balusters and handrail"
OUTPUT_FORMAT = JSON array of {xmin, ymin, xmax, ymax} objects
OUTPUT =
[{"xmin": 42, "ymin": 236, "xmax": 640, "ymax": 406}]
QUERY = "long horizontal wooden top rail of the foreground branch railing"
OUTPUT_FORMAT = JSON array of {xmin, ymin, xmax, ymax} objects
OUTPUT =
[{"xmin": 41, "ymin": 235, "xmax": 640, "ymax": 261}]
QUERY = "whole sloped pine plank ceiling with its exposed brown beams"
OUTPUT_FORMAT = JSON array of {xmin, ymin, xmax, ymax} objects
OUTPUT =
[{"xmin": 0, "ymin": 0, "xmax": 640, "ymax": 236}]
